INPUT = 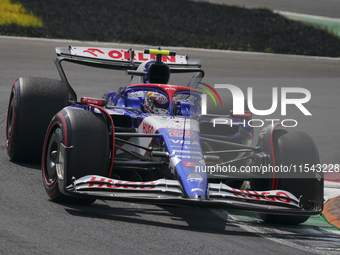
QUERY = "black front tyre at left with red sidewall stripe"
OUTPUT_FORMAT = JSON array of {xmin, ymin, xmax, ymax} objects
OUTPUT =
[{"xmin": 42, "ymin": 108, "xmax": 110, "ymax": 204}]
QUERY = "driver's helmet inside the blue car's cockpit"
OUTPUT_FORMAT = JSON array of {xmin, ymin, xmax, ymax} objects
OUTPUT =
[{"xmin": 143, "ymin": 91, "xmax": 170, "ymax": 114}]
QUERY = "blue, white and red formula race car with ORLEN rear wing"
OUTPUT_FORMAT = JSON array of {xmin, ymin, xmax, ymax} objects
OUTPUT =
[{"xmin": 6, "ymin": 46, "xmax": 323, "ymax": 224}]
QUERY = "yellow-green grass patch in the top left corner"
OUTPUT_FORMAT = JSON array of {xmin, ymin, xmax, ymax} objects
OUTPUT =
[{"xmin": 0, "ymin": 0, "xmax": 43, "ymax": 27}]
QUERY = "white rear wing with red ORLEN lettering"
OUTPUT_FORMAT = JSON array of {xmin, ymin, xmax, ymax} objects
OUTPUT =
[{"xmin": 55, "ymin": 46, "xmax": 204, "ymax": 100}]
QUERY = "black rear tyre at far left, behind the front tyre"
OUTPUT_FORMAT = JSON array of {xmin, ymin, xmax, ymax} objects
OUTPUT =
[{"xmin": 6, "ymin": 78, "xmax": 69, "ymax": 163}]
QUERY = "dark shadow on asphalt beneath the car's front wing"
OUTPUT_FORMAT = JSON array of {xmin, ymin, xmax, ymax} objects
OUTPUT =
[{"xmin": 59, "ymin": 202, "xmax": 254, "ymax": 236}]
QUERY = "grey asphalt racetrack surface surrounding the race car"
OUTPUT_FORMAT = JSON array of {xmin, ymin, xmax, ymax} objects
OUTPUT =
[{"xmin": 0, "ymin": 37, "xmax": 340, "ymax": 255}]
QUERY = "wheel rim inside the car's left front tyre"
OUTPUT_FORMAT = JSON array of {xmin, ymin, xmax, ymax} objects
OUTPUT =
[{"xmin": 44, "ymin": 126, "xmax": 62, "ymax": 186}]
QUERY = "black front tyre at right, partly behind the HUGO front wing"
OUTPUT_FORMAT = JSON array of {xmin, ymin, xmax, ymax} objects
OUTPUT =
[{"xmin": 261, "ymin": 130, "xmax": 323, "ymax": 225}]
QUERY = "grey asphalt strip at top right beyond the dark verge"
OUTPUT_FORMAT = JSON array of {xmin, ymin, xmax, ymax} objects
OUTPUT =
[{"xmin": 202, "ymin": 0, "xmax": 340, "ymax": 18}]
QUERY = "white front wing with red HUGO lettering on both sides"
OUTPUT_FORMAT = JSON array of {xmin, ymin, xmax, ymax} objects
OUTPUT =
[{"xmin": 59, "ymin": 175, "xmax": 322, "ymax": 216}]
